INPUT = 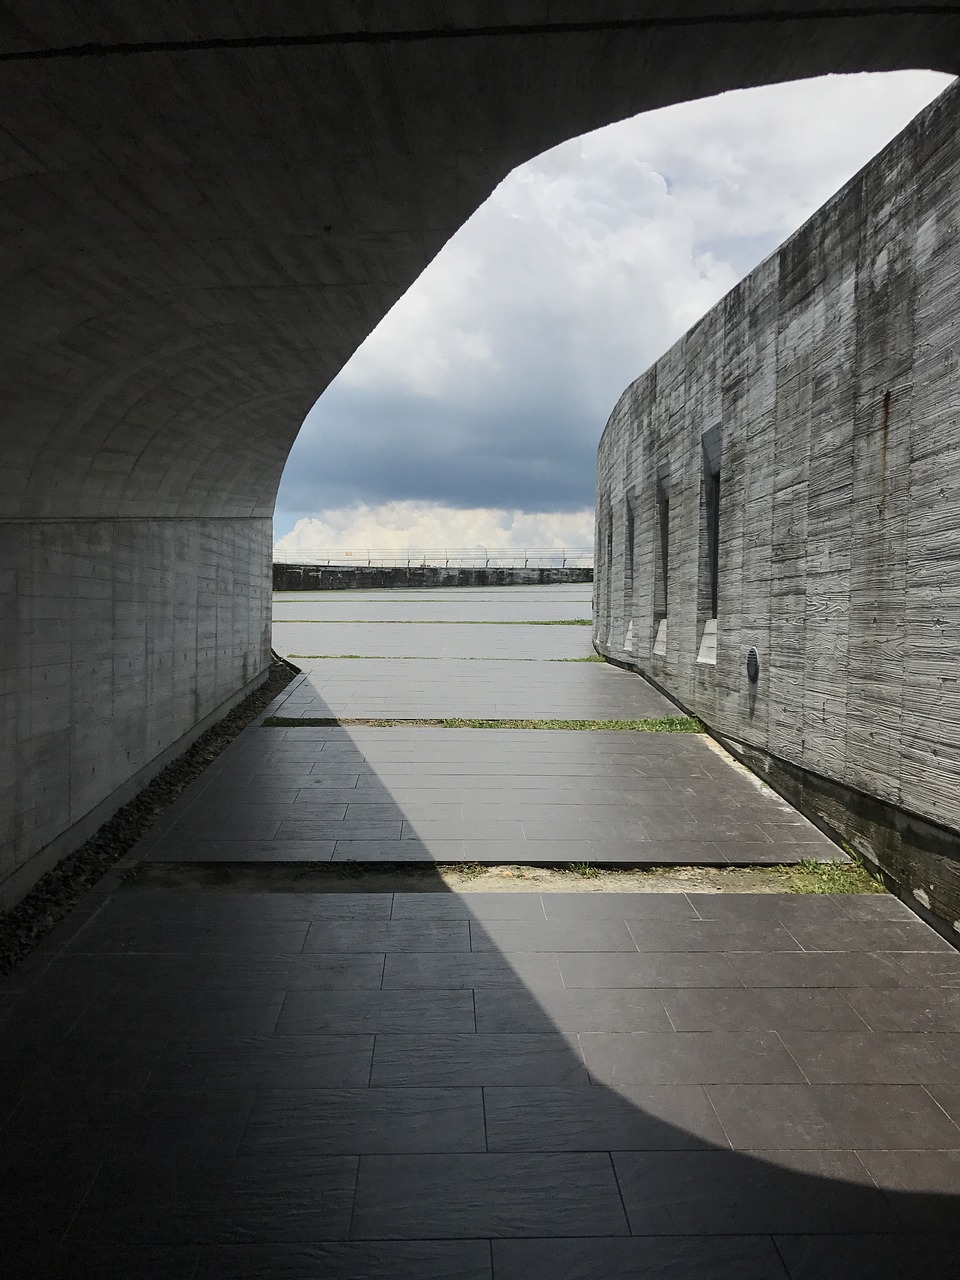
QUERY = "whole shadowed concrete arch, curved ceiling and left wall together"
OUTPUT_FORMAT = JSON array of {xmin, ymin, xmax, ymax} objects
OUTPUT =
[{"xmin": 0, "ymin": 0, "xmax": 960, "ymax": 901}]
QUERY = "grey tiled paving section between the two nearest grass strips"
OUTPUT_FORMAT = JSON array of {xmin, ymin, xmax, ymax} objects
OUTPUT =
[{"xmin": 143, "ymin": 721, "xmax": 839, "ymax": 870}]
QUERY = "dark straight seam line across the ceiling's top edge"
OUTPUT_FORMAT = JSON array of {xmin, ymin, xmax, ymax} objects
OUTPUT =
[{"xmin": 0, "ymin": 4, "xmax": 960, "ymax": 63}]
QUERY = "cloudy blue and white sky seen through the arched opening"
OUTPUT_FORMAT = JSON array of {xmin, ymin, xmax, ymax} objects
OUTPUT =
[{"xmin": 274, "ymin": 72, "xmax": 950, "ymax": 556}]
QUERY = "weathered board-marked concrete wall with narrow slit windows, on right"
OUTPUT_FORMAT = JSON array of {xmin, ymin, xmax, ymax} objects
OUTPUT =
[{"xmin": 595, "ymin": 87, "xmax": 960, "ymax": 922}]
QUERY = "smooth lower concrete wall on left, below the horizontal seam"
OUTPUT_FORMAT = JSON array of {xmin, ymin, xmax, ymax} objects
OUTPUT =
[{"xmin": 0, "ymin": 520, "xmax": 273, "ymax": 908}]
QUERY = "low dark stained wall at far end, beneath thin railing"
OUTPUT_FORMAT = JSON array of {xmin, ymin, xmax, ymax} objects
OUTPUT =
[{"xmin": 274, "ymin": 564, "xmax": 594, "ymax": 591}]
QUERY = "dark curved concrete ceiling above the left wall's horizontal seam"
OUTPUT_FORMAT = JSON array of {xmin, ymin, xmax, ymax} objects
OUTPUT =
[{"xmin": 0, "ymin": 0, "xmax": 960, "ymax": 518}]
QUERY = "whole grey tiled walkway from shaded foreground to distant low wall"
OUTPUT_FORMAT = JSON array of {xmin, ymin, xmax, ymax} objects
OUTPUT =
[{"xmin": 0, "ymin": 588, "xmax": 960, "ymax": 1280}]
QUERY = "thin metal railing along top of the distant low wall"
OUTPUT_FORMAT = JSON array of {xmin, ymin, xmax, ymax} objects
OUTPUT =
[{"xmin": 274, "ymin": 547, "xmax": 594, "ymax": 568}]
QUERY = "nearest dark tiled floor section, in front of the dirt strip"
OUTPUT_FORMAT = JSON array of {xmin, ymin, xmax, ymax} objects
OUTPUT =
[{"xmin": 0, "ymin": 887, "xmax": 960, "ymax": 1280}]
